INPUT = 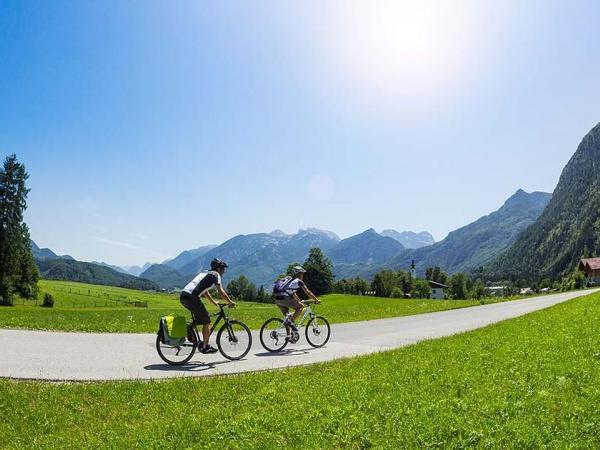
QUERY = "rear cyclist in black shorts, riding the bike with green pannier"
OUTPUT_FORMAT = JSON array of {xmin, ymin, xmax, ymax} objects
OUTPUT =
[{"xmin": 179, "ymin": 258, "xmax": 235, "ymax": 353}]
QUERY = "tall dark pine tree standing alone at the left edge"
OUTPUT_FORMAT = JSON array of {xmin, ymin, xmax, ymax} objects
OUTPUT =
[{"xmin": 0, "ymin": 155, "xmax": 39, "ymax": 305}]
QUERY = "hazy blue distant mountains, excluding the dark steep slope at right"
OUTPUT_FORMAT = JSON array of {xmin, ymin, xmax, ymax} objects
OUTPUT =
[{"xmin": 29, "ymin": 190, "xmax": 550, "ymax": 289}]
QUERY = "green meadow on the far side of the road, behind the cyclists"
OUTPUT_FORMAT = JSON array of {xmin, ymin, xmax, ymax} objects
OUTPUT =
[{"xmin": 0, "ymin": 281, "xmax": 480, "ymax": 333}]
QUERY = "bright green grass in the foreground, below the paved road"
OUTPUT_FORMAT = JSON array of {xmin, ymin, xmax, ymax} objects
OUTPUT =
[{"xmin": 0, "ymin": 294, "xmax": 600, "ymax": 449}]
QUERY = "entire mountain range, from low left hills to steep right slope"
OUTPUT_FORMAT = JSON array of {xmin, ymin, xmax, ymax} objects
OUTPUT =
[{"xmin": 32, "ymin": 124, "xmax": 600, "ymax": 288}]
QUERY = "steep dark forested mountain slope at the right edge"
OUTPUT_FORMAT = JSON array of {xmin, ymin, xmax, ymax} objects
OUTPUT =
[{"xmin": 486, "ymin": 123, "xmax": 600, "ymax": 280}]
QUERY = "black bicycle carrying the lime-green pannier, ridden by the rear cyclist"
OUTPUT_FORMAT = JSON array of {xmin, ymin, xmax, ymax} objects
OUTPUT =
[{"xmin": 156, "ymin": 303, "xmax": 252, "ymax": 366}]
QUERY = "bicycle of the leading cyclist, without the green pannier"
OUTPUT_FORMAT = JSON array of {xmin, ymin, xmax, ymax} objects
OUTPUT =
[{"xmin": 260, "ymin": 300, "xmax": 331, "ymax": 353}]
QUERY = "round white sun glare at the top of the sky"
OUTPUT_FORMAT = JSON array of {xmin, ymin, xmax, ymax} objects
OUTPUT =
[{"xmin": 326, "ymin": 1, "xmax": 480, "ymax": 102}]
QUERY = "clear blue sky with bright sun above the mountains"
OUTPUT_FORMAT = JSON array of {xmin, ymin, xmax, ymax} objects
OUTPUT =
[{"xmin": 0, "ymin": 1, "xmax": 600, "ymax": 264}]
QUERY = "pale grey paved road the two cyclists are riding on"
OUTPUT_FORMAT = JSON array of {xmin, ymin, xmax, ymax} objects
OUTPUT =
[{"xmin": 0, "ymin": 291, "xmax": 596, "ymax": 381}]
